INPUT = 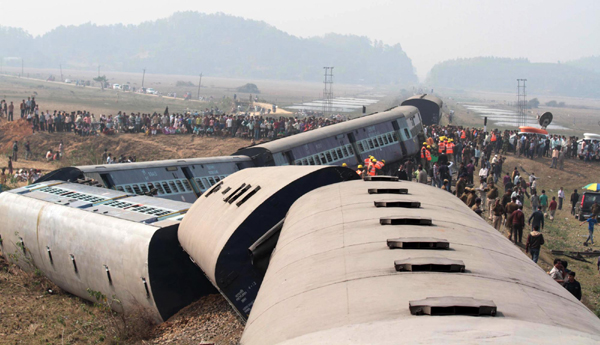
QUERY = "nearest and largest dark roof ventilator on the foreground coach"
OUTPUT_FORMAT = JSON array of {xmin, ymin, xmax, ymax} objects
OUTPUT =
[{"xmin": 408, "ymin": 296, "xmax": 498, "ymax": 316}]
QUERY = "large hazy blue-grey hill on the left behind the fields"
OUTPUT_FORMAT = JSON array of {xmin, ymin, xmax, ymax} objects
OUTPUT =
[{"xmin": 0, "ymin": 12, "xmax": 417, "ymax": 84}]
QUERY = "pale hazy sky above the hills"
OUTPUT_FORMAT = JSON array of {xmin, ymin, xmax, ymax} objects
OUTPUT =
[{"xmin": 0, "ymin": 0, "xmax": 600, "ymax": 77}]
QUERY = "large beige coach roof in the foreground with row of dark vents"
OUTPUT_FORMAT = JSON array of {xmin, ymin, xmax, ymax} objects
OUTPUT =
[{"xmin": 240, "ymin": 176, "xmax": 600, "ymax": 345}]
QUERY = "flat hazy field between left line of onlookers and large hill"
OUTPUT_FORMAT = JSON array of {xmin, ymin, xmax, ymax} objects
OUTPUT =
[{"xmin": 0, "ymin": 67, "xmax": 382, "ymax": 114}]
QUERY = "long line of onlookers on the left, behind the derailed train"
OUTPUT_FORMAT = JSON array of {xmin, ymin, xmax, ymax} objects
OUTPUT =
[{"xmin": 0, "ymin": 97, "xmax": 346, "ymax": 140}]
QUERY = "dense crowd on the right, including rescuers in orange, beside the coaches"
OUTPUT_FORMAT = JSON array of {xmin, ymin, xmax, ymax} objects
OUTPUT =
[{"xmin": 398, "ymin": 125, "xmax": 600, "ymax": 299}]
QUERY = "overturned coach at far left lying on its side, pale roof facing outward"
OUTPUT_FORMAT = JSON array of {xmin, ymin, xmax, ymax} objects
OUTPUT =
[{"xmin": 0, "ymin": 181, "xmax": 216, "ymax": 322}]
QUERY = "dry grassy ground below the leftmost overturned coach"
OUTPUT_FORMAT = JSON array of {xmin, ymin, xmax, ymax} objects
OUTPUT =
[{"xmin": 0, "ymin": 251, "xmax": 152, "ymax": 344}]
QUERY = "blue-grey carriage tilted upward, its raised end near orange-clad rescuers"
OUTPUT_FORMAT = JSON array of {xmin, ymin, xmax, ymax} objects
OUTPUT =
[{"xmin": 235, "ymin": 106, "xmax": 423, "ymax": 172}]
